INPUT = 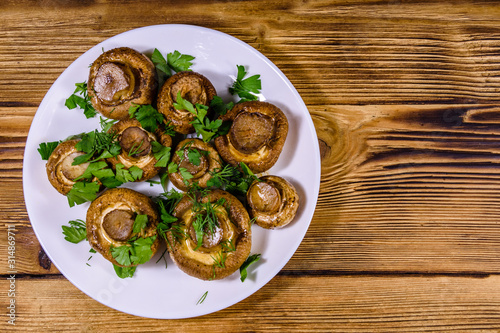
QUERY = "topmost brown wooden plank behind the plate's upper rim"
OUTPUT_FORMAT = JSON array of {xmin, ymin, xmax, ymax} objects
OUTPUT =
[{"xmin": 0, "ymin": 1, "xmax": 500, "ymax": 105}]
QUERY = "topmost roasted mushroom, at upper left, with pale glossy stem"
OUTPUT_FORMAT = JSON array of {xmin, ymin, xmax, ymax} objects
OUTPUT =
[{"xmin": 87, "ymin": 47, "xmax": 158, "ymax": 119}]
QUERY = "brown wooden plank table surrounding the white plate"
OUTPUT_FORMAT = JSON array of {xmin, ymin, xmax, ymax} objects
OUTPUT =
[{"xmin": 0, "ymin": 0, "xmax": 500, "ymax": 332}]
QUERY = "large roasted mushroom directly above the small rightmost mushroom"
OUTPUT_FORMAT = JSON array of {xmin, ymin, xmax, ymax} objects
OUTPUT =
[{"xmin": 215, "ymin": 101, "xmax": 288, "ymax": 173}]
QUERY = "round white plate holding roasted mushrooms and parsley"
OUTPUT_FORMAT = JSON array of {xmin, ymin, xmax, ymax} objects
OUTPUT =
[{"xmin": 23, "ymin": 25, "xmax": 320, "ymax": 319}]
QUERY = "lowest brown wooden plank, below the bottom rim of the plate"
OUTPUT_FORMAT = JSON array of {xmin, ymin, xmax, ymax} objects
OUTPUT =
[{"xmin": 0, "ymin": 275, "xmax": 500, "ymax": 333}]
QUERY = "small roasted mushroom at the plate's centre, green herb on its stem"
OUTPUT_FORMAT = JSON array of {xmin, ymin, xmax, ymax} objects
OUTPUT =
[{"xmin": 168, "ymin": 138, "xmax": 222, "ymax": 191}]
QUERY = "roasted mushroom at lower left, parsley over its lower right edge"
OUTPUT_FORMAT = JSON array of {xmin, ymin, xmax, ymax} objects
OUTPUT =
[{"xmin": 86, "ymin": 188, "xmax": 160, "ymax": 267}]
